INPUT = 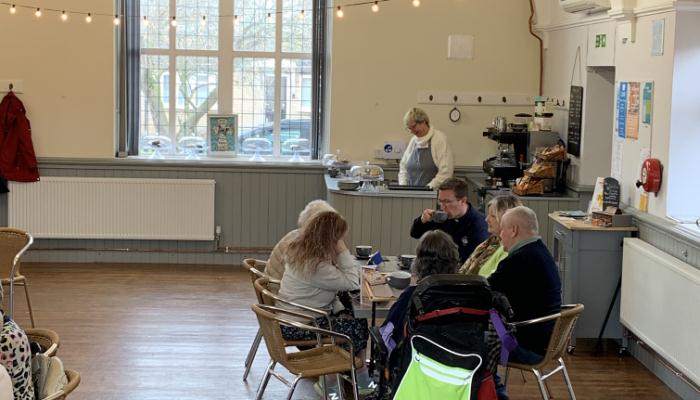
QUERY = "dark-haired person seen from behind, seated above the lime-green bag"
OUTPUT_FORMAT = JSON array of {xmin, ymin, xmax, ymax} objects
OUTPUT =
[{"xmin": 380, "ymin": 230, "xmax": 459, "ymax": 351}]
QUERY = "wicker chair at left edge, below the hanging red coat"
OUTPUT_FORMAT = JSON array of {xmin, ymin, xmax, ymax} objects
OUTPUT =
[{"xmin": 0, "ymin": 228, "xmax": 35, "ymax": 328}]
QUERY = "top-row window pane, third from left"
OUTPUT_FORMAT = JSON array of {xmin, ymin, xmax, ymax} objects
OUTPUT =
[{"xmin": 233, "ymin": 0, "xmax": 277, "ymax": 51}]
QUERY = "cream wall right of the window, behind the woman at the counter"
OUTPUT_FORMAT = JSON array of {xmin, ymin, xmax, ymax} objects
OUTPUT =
[{"xmin": 330, "ymin": 0, "xmax": 538, "ymax": 165}]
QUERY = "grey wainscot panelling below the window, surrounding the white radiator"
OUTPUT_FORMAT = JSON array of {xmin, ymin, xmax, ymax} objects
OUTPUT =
[{"xmin": 0, "ymin": 160, "xmax": 326, "ymax": 264}]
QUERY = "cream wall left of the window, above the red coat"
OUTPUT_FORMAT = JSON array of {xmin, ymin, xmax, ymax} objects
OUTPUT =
[{"xmin": 0, "ymin": 0, "xmax": 115, "ymax": 158}]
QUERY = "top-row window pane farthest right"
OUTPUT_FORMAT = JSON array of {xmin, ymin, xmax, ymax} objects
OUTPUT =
[{"xmin": 282, "ymin": 0, "xmax": 313, "ymax": 53}]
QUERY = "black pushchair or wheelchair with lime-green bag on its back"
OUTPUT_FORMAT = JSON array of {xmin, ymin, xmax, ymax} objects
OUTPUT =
[{"xmin": 370, "ymin": 275, "xmax": 512, "ymax": 400}]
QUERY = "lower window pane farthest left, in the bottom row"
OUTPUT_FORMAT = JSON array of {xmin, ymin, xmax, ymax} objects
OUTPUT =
[{"xmin": 139, "ymin": 55, "xmax": 169, "ymax": 137}]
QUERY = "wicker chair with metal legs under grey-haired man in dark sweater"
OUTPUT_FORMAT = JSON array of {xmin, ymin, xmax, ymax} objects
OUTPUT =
[{"xmin": 505, "ymin": 304, "xmax": 583, "ymax": 400}]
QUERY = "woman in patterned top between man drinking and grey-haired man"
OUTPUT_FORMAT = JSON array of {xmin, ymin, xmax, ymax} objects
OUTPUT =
[{"xmin": 459, "ymin": 194, "xmax": 523, "ymax": 278}]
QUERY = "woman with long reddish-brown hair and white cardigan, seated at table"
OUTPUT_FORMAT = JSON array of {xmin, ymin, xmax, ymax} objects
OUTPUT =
[{"xmin": 278, "ymin": 211, "xmax": 373, "ymax": 394}]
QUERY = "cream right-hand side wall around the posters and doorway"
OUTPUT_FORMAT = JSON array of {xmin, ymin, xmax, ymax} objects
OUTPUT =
[{"xmin": 537, "ymin": 0, "xmax": 675, "ymax": 217}]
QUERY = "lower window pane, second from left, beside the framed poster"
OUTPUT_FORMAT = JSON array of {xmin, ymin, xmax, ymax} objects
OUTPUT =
[{"xmin": 175, "ymin": 57, "xmax": 219, "ymax": 141}]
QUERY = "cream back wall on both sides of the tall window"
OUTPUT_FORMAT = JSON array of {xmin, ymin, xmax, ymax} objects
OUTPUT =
[{"xmin": 0, "ymin": 0, "xmax": 537, "ymax": 165}]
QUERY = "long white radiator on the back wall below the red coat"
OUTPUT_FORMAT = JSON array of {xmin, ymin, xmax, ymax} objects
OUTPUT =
[{"xmin": 8, "ymin": 177, "xmax": 215, "ymax": 240}]
